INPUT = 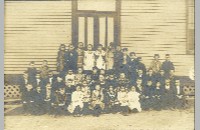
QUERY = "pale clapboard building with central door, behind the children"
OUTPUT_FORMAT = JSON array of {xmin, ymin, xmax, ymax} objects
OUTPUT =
[{"xmin": 4, "ymin": 0, "xmax": 194, "ymax": 80}]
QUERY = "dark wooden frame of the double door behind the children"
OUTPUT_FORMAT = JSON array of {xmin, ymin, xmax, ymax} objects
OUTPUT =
[{"xmin": 71, "ymin": 0, "xmax": 121, "ymax": 47}]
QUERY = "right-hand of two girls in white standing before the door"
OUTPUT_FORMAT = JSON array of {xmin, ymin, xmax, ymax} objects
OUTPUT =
[{"xmin": 94, "ymin": 44, "xmax": 106, "ymax": 70}]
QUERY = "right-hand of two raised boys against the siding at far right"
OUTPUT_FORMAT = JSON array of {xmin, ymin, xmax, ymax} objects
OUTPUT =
[{"xmin": 161, "ymin": 54, "xmax": 175, "ymax": 77}]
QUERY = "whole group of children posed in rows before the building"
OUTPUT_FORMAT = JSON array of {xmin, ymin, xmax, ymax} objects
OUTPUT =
[{"xmin": 20, "ymin": 43, "xmax": 185, "ymax": 116}]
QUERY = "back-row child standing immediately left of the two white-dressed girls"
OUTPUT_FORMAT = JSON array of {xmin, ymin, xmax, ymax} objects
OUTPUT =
[{"xmin": 76, "ymin": 42, "xmax": 84, "ymax": 67}]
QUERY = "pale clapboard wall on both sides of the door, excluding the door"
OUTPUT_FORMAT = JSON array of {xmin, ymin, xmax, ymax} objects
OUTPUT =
[{"xmin": 4, "ymin": 0, "xmax": 194, "ymax": 76}]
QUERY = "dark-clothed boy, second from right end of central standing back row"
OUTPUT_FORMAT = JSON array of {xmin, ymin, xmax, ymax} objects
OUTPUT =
[{"xmin": 128, "ymin": 52, "xmax": 138, "ymax": 85}]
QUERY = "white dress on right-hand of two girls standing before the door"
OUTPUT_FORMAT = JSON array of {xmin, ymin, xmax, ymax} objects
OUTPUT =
[{"xmin": 95, "ymin": 50, "xmax": 106, "ymax": 69}]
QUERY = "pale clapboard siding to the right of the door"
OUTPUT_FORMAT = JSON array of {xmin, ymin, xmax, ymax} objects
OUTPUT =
[{"xmin": 121, "ymin": 0, "xmax": 194, "ymax": 76}]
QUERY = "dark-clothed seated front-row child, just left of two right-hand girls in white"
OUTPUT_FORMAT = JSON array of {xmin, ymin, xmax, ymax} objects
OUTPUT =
[{"xmin": 105, "ymin": 86, "xmax": 117, "ymax": 113}]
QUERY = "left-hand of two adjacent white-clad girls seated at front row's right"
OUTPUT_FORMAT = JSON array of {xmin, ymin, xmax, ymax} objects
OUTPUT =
[{"xmin": 117, "ymin": 86, "xmax": 128, "ymax": 116}]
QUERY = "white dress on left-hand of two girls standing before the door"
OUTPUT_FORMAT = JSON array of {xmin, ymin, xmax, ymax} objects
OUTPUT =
[{"xmin": 83, "ymin": 51, "xmax": 95, "ymax": 70}]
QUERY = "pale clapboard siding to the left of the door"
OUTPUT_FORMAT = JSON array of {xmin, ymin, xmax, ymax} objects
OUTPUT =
[{"xmin": 4, "ymin": 1, "xmax": 71, "ymax": 74}]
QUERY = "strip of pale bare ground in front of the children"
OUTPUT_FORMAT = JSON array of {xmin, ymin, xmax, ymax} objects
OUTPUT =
[{"xmin": 5, "ymin": 108, "xmax": 194, "ymax": 130}]
